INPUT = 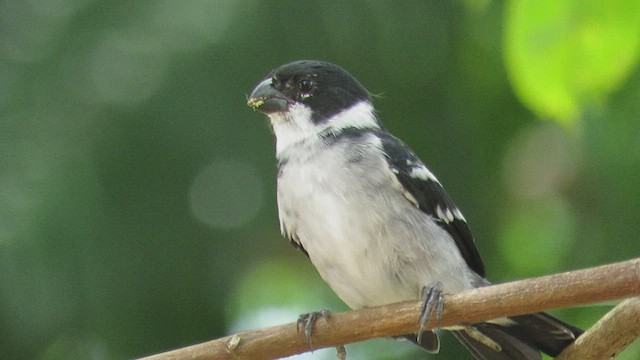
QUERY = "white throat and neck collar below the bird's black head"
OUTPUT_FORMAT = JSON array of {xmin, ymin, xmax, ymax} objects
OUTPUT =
[{"xmin": 269, "ymin": 101, "xmax": 380, "ymax": 158}]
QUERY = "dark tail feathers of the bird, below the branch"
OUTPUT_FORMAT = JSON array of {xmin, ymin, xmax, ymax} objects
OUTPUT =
[{"xmin": 452, "ymin": 313, "xmax": 582, "ymax": 360}]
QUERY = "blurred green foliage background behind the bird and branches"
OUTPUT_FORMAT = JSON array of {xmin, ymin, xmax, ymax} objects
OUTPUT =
[{"xmin": 0, "ymin": 0, "xmax": 640, "ymax": 360}]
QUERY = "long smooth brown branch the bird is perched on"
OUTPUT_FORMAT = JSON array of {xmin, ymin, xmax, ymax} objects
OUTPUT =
[{"xmin": 144, "ymin": 258, "xmax": 640, "ymax": 360}]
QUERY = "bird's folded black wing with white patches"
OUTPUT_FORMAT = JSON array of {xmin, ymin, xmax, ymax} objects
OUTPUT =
[{"xmin": 377, "ymin": 132, "xmax": 485, "ymax": 277}]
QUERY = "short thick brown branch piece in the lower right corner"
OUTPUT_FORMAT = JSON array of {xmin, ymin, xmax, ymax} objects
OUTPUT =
[{"xmin": 556, "ymin": 297, "xmax": 640, "ymax": 360}]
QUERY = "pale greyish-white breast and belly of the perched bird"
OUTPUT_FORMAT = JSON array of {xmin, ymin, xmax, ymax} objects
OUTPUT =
[{"xmin": 278, "ymin": 134, "xmax": 471, "ymax": 308}]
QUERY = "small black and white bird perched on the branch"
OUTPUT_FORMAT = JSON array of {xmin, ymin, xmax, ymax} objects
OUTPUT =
[{"xmin": 248, "ymin": 61, "xmax": 581, "ymax": 360}]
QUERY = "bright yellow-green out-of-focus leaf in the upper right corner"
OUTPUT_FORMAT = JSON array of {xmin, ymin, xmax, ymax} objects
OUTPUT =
[{"xmin": 504, "ymin": 0, "xmax": 640, "ymax": 125}]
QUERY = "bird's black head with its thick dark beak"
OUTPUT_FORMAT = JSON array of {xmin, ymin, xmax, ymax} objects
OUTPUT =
[{"xmin": 247, "ymin": 60, "xmax": 371, "ymax": 123}]
